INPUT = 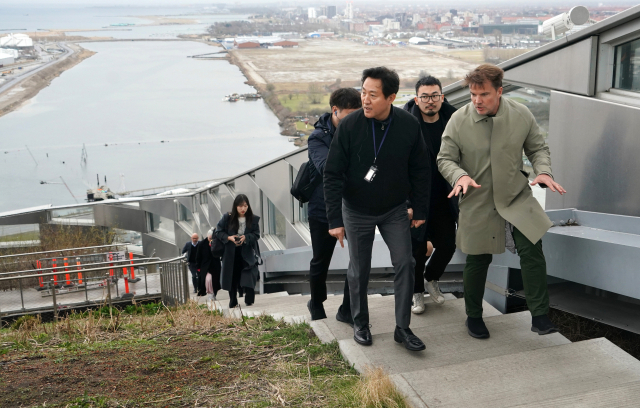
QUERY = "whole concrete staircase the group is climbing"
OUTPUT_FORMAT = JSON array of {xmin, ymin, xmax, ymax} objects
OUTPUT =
[{"xmin": 203, "ymin": 292, "xmax": 640, "ymax": 408}]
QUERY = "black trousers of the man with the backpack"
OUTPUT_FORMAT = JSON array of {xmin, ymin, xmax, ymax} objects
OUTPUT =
[{"xmin": 309, "ymin": 218, "xmax": 351, "ymax": 318}]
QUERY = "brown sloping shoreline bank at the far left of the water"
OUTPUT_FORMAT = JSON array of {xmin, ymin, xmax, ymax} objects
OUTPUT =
[{"xmin": 0, "ymin": 43, "xmax": 95, "ymax": 117}]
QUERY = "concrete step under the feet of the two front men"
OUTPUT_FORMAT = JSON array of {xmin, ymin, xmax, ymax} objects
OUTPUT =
[{"xmin": 339, "ymin": 312, "xmax": 571, "ymax": 374}]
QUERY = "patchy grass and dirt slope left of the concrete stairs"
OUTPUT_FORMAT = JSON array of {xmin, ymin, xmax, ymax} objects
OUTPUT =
[{"xmin": 0, "ymin": 303, "xmax": 361, "ymax": 407}]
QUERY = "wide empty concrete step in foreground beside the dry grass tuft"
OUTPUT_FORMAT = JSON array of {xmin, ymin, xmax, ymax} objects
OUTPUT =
[{"xmin": 391, "ymin": 336, "xmax": 640, "ymax": 408}]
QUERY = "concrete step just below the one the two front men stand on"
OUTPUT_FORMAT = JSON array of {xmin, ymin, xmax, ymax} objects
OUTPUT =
[{"xmin": 314, "ymin": 295, "xmax": 501, "ymax": 341}]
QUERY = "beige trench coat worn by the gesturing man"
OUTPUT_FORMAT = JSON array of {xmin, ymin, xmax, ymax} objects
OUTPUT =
[{"xmin": 438, "ymin": 98, "xmax": 553, "ymax": 255}]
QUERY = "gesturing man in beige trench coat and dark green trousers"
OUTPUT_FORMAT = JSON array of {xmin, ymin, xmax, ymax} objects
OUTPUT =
[{"xmin": 437, "ymin": 64, "xmax": 566, "ymax": 338}]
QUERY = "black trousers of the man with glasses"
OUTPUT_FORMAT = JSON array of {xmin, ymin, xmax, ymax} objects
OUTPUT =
[{"xmin": 411, "ymin": 208, "xmax": 456, "ymax": 293}]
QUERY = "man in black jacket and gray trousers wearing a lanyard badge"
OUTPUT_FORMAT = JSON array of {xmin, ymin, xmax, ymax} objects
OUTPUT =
[{"xmin": 324, "ymin": 67, "xmax": 431, "ymax": 351}]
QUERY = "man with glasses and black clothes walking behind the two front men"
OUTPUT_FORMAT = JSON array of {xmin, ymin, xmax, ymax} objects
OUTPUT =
[{"xmin": 404, "ymin": 76, "xmax": 458, "ymax": 314}]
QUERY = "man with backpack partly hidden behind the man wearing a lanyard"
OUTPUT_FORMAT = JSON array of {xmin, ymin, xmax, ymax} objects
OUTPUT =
[{"xmin": 307, "ymin": 88, "xmax": 362, "ymax": 326}]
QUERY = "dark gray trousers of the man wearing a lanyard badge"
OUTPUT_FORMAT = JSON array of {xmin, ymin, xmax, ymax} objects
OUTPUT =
[{"xmin": 342, "ymin": 204, "xmax": 415, "ymax": 329}]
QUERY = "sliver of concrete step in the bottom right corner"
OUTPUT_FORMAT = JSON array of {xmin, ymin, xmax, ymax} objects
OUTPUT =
[{"xmin": 516, "ymin": 381, "xmax": 640, "ymax": 408}]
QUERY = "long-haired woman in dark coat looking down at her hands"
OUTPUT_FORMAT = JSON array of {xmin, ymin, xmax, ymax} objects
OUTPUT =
[{"xmin": 216, "ymin": 194, "xmax": 260, "ymax": 308}]
